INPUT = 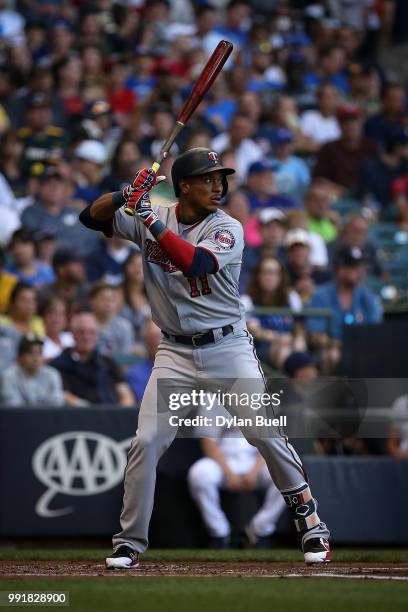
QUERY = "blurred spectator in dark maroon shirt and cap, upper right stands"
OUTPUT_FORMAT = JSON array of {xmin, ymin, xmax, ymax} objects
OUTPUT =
[{"xmin": 313, "ymin": 106, "xmax": 378, "ymax": 195}]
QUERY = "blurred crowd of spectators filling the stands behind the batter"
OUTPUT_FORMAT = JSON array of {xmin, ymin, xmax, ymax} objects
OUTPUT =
[{"xmin": 0, "ymin": 0, "xmax": 408, "ymax": 454}]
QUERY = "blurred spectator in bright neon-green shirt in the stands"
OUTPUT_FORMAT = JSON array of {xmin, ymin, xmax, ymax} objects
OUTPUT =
[{"xmin": 305, "ymin": 179, "xmax": 338, "ymax": 242}]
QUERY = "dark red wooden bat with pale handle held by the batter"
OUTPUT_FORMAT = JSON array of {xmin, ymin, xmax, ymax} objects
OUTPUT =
[{"xmin": 124, "ymin": 40, "xmax": 233, "ymax": 215}]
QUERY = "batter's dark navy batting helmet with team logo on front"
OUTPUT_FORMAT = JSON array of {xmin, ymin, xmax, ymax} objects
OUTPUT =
[{"xmin": 171, "ymin": 147, "xmax": 235, "ymax": 197}]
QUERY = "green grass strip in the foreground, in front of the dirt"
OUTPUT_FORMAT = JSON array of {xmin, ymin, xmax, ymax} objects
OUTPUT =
[{"xmin": 0, "ymin": 576, "xmax": 408, "ymax": 612}]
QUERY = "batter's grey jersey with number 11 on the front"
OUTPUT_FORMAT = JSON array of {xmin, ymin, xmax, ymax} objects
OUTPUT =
[{"xmin": 113, "ymin": 204, "xmax": 244, "ymax": 335}]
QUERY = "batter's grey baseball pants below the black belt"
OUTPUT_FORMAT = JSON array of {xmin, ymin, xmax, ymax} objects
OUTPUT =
[{"xmin": 113, "ymin": 322, "xmax": 329, "ymax": 553}]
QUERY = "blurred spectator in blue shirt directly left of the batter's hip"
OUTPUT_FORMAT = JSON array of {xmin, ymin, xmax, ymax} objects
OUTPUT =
[{"xmin": 125, "ymin": 319, "xmax": 162, "ymax": 402}]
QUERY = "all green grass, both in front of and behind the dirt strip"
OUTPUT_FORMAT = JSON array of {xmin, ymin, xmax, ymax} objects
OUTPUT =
[{"xmin": 0, "ymin": 548, "xmax": 408, "ymax": 612}]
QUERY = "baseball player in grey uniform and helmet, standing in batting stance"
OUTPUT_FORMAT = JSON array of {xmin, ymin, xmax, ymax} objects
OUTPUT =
[{"xmin": 80, "ymin": 148, "xmax": 330, "ymax": 569}]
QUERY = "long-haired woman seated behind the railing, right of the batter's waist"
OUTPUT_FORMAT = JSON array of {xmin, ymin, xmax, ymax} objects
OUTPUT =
[{"xmin": 242, "ymin": 257, "xmax": 305, "ymax": 367}]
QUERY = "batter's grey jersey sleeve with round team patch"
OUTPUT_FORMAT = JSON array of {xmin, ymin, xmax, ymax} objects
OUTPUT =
[{"xmin": 197, "ymin": 218, "xmax": 244, "ymax": 272}]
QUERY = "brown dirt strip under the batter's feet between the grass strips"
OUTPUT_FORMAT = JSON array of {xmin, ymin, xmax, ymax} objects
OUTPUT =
[{"xmin": 0, "ymin": 561, "xmax": 408, "ymax": 581}]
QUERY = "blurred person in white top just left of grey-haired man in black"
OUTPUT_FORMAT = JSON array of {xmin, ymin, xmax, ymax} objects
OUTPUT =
[{"xmin": 39, "ymin": 296, "xmax": 74, "ymax": 361}]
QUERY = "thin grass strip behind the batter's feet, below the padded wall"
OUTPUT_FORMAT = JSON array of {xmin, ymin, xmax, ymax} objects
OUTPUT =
[{"xmin": 0, "ymin": 544, "xmax": 408, "ymax": 563}]
